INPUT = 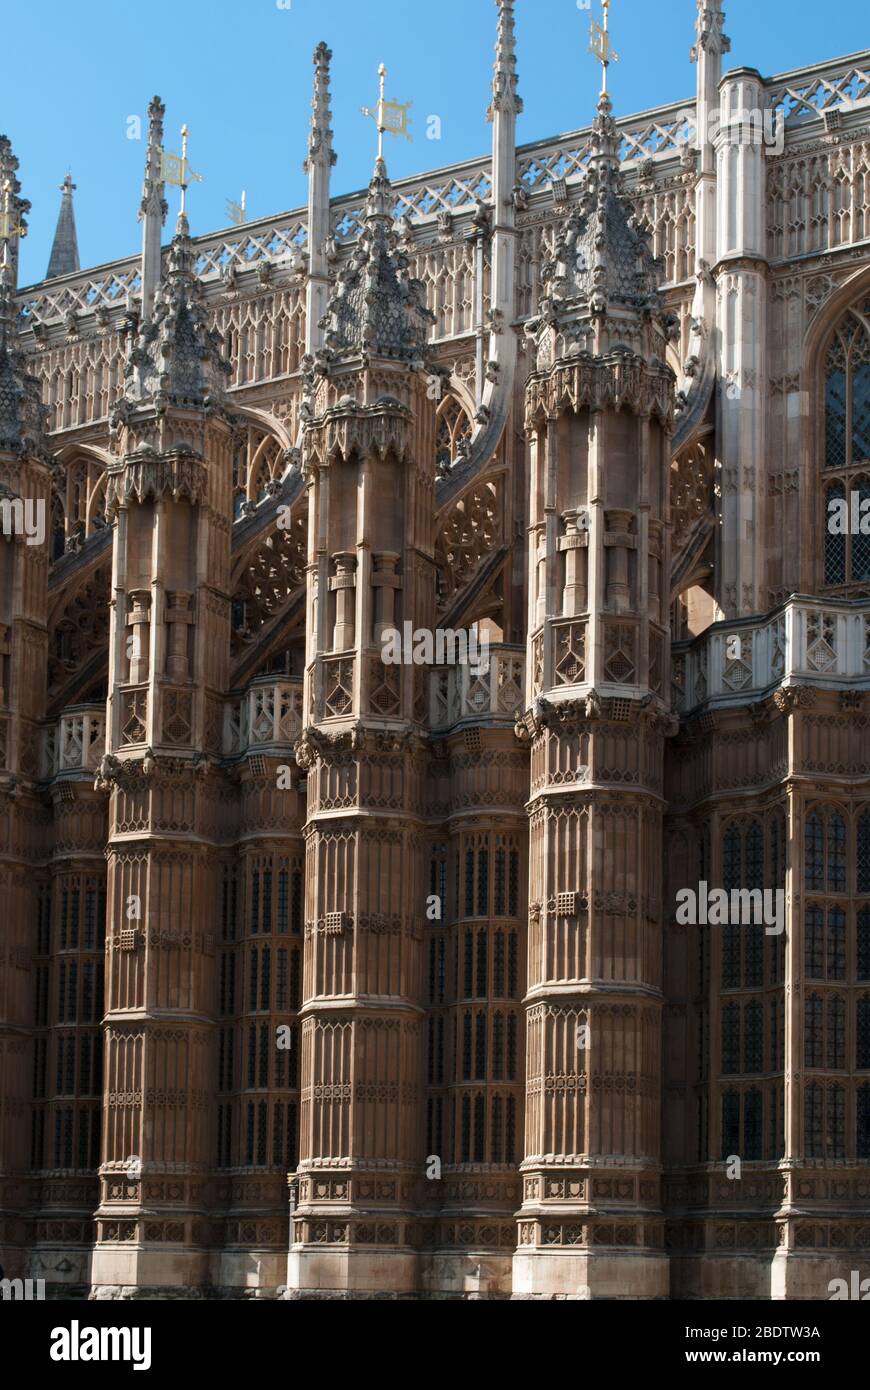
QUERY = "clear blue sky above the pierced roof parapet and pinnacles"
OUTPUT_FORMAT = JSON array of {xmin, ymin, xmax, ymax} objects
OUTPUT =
[{"xmin": 6, "ymin": 0, "xmax": 870, "ymax": 284}]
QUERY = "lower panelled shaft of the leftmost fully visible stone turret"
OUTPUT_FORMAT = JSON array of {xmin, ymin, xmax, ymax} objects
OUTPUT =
[{"xmin": 93, "ymin": 833, "xmax": 214, "ymax": 1289}]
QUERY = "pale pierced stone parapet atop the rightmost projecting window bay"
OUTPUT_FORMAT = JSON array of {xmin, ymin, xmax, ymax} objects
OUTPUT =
[{"xmin": 671, "ymin": 595, "xmax": 870, "ymax": 713}]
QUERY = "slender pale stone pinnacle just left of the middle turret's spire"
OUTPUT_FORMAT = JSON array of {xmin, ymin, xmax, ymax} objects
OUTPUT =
[{"xmin": 303, "ymin": 43, "xmax": 336, "ymax": 354}]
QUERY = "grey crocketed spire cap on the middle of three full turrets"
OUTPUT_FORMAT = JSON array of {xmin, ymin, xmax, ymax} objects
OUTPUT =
[{"xmin": 321, "ymin": 158, "xmax": 435, "ymax": 370}]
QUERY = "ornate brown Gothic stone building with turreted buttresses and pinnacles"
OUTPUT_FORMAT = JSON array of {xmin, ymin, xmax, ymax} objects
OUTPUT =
[{"xmin": 0, "ymin": 0, "xmax": 870, "ymax": 1298}]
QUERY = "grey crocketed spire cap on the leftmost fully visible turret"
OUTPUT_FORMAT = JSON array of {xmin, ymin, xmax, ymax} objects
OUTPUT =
[{"xmin": 121, "ymin": 213, "xmax": 231, "ymax": 410}]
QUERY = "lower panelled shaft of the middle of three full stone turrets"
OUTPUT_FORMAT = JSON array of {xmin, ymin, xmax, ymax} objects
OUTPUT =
[{"xmin": 288, "ymin": 756, "xmax": 425, "ymax": 1291}]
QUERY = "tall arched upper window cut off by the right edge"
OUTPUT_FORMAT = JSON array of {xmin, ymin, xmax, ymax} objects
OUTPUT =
[{"xmin": 821, "ymin": 299, "xmax": 870, "ymax": 596}]
